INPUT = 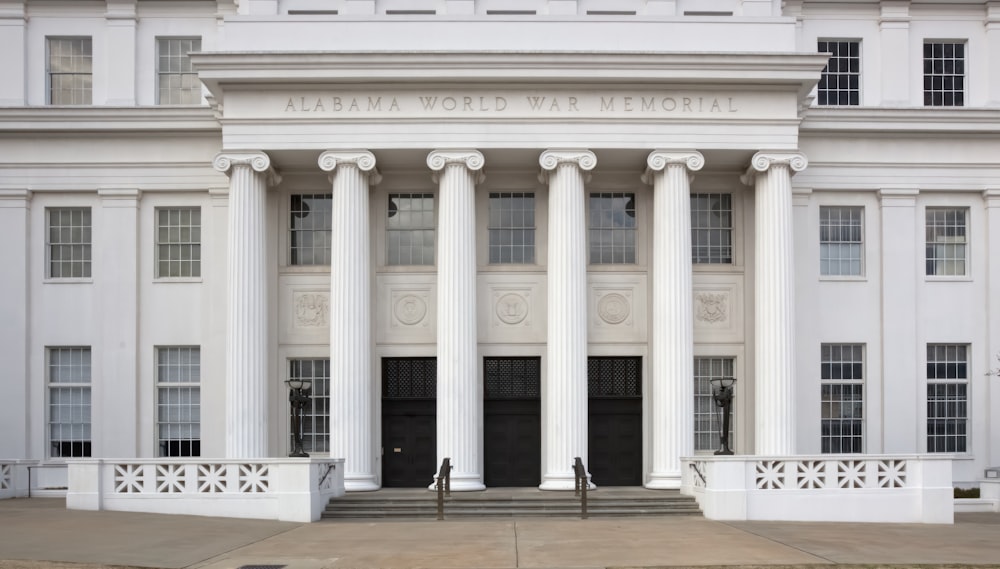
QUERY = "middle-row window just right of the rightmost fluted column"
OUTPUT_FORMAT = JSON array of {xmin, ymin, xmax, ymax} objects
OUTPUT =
[{"xmin": 819, "ymin": 206, "xmax": 864, "ymax": 276}]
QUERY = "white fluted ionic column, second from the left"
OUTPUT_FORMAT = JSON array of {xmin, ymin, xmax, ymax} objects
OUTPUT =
[{"xmin": 319, "ymin": 150, "xmax": 381, "ymax": 492}]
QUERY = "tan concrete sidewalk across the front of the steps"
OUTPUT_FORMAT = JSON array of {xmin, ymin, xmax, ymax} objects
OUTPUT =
[{"xmin": 0, "ymin": 498, "xmax": 1000, "ymax": 569}]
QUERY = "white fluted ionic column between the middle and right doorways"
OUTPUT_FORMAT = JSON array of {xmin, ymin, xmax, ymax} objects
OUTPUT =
[{"xmin": 539, "ymin": 150, "xmax": 597, "ymax": 490}]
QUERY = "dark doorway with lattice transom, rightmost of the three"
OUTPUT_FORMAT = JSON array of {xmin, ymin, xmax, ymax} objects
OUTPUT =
[{"xmin": 587, "ymin": 357, "xmax": 642, "ymax": 486}]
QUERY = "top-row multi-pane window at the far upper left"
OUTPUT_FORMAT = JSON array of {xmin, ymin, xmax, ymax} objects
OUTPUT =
[{"xmin": 46, "ymin": 38, "xmax": 94, "ymax": 105}]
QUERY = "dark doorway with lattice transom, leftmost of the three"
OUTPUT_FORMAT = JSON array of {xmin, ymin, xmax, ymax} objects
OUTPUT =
[{"xmin": 382, "ymin": 358, "xmax": 437, "ymax": 488}]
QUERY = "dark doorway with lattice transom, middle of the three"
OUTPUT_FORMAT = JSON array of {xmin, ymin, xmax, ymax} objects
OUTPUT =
[{"xmin": 483, "ymin": 358, "xmax": 542, "ymax": 487}]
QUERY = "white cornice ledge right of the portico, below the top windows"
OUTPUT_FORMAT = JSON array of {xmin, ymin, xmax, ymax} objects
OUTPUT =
[{"xmin": 800, "ymin": 107, "xmax": 1000, "ymax": 135}]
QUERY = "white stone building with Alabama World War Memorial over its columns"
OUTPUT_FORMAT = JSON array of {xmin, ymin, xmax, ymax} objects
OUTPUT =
[{"xmin": 0, "ymin": 0, "xmax": 1000, "ymax": 492}]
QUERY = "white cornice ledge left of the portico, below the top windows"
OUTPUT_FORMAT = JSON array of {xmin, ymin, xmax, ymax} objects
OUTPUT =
[{"xmin": 0, "ymin": 107, "xmax": 222, "ymax": 134}]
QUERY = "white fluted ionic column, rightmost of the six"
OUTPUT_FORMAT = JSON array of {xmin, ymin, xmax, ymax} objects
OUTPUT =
[{"xmin": 743, "ymin": 152, "xmax": 806, "ymax": 456}]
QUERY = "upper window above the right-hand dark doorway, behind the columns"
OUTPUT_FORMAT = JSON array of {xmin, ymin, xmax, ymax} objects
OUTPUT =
[{"xmin": 590, "ymin": 193, "xmax": 636, "ymax": 265}]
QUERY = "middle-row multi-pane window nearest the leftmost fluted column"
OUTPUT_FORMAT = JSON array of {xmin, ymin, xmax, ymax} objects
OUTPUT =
[{"xmin": 156, "ymin": 207, "xmax": 201, "ymax": 278}]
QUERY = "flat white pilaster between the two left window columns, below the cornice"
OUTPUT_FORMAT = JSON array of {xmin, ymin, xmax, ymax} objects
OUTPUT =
[{"xmin": 94, "ymin": 190, "xmax": 141, "ymax": 458}]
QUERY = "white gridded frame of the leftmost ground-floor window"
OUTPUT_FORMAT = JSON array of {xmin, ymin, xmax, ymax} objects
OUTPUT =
[{"xmin": 45, "ymin": 346, "xmax": 94, "ymax": 460}]
